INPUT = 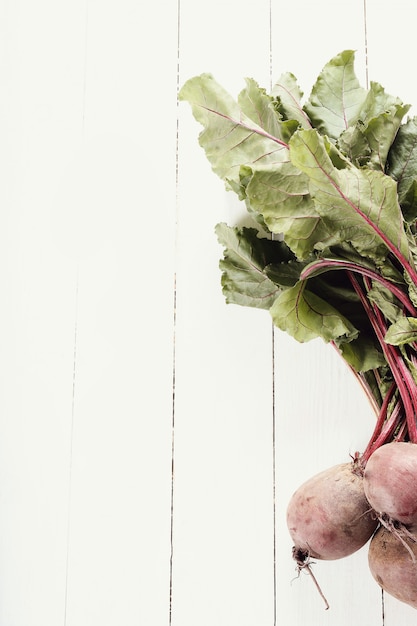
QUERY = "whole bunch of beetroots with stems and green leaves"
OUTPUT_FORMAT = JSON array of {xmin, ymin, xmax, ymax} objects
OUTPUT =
[{"xmin": 179, "ymin": 50, "xmax": 417, "ymax": 608}]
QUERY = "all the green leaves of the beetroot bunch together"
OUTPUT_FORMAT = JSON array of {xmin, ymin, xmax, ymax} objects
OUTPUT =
[{"xmin": 180, "ymin": 50, "xmax": 417, "ymax": 404}]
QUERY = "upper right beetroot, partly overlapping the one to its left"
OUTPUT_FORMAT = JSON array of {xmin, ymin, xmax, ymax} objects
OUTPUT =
[{"xmin": 363, "ymin": 442, "xmax": 417, "ymax": 525}]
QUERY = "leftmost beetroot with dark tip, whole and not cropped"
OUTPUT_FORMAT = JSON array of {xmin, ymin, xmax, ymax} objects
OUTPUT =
[{"xmin": 287, "ymin": 463, "xmax": 378, "ymax": 560}]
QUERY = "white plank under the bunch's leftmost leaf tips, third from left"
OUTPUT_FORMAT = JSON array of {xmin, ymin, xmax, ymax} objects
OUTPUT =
[{"xmin": 172, "ymin": 0, "xmax": 273, "ymax": 626}]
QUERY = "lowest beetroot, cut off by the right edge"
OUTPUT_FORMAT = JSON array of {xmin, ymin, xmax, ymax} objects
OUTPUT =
[{"xmin": 368, "ymin": 526, "xmax": 417, "ymax": 609}]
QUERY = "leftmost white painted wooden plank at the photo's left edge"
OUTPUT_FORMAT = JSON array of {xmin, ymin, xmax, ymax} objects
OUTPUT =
[{"xmin": 0, "ymin": 0, "xmax": 84, "ymax": 626}]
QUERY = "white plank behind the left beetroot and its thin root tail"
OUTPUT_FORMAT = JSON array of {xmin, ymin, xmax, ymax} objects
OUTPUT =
[{"xmin": 272, "ymin": 0, "xmax": 382, "ymax": 625}]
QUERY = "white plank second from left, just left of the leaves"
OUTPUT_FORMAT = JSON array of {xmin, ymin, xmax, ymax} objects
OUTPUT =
[{"xmin": 61, "ymin": 0, "xmax": 177, "ymax": 625}]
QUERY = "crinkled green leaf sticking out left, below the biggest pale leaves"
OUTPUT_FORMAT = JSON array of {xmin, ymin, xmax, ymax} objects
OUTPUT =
[{"xmin": 216, "ymin": 223, "xmax": 282, "ymax": 309}]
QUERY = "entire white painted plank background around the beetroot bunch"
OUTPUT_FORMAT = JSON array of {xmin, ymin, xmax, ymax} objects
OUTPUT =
[{"xmin": 0, "ymin": 0, "xmax": 417, "ymax": 626}]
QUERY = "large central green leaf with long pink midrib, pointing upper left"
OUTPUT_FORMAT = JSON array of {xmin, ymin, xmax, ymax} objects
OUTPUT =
[{"xmin": 290, "ymin": 130, "xmax": 409, "ymax": 261}]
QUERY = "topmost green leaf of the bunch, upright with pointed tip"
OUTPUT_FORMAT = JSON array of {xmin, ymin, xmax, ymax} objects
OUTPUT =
[{"xmin": 304, "ymin": 50, "xmax": 367, "ymax": 139}]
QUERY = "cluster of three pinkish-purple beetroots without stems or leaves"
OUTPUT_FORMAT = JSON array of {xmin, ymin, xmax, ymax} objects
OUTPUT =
[{"xmin": 287, "ymin": 441, "xmax": 417, "ymax": 608}]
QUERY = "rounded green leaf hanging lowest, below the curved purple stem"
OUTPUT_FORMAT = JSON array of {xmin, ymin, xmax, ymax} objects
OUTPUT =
[{"xmin": 270, "ymin": 281, "xmax": 358, "ymax": 343}]
